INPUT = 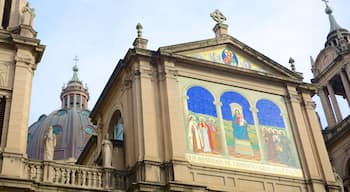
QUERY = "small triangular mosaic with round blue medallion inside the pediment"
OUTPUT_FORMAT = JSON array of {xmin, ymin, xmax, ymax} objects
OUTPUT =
[{"xmin": 183, "ymin": 46, "xmax": 268, "ymax": 72}]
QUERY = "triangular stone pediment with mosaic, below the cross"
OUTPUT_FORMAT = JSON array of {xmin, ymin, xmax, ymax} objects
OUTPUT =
[{"xmin": 160, "ymin": 37, "xmax": 302, "ymax": 80}]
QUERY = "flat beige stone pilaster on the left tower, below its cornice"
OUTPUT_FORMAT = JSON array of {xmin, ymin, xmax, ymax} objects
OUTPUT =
[{"xmin": 1, "ymin": 47, "xmax": 35, "ymax": 177}]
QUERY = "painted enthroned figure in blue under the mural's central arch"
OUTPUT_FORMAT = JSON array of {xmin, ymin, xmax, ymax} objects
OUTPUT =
[{"xmin": 231, "ymin": 103, "xmax": 254, "ymax": 156}]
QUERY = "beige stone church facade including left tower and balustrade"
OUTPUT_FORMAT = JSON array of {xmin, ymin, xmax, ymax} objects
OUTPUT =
[{"xmin": 0, "ymin": 0, "xmax": 341, "ymax": 192}]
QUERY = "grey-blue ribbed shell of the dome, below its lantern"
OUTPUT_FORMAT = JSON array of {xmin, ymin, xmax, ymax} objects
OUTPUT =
[{"xmin": 27, "ymin": 109, "xmax": 96, "ymax": 161}]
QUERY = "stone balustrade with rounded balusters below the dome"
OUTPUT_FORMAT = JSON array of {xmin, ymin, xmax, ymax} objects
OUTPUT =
[{"xmin": 23, "ymin": 160, "xmax": 118, "ymax": 190}]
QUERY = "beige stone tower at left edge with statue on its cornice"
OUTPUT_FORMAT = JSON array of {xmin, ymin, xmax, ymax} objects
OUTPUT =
[{"xmin": 0, "ymin": 0, "xmax": 45, "ymax": 177}]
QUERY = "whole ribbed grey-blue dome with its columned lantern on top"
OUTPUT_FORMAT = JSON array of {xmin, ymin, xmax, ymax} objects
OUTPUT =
[{"xmin": 27, "ymin": 65, "xmax": 96, "ymax": 161}]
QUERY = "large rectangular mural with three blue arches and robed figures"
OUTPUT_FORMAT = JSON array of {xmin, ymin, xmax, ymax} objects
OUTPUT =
[{"xmin": 178, "ymin": 77, "xmax": 302, "ymax": 177}]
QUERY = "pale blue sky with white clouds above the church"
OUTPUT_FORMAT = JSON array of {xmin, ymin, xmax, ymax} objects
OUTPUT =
[{"xmin": 29, "ymin": 0, "xmax": 350, "ymax": 126}]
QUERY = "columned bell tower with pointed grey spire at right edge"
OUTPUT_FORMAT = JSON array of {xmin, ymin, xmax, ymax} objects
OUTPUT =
[{"xmin": 311, "ymin": 0, "xmax": 350, "ymax": 129}]
